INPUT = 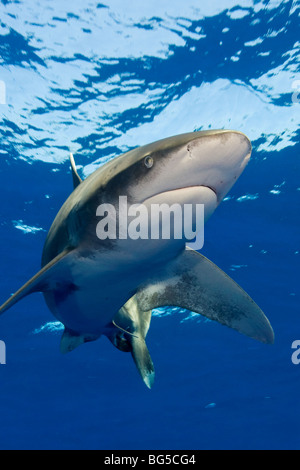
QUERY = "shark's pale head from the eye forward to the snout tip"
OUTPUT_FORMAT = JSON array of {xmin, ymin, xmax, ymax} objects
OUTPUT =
[{"xmin": 101, "ymin": 130, "xmax": 251, "ymax": 218}]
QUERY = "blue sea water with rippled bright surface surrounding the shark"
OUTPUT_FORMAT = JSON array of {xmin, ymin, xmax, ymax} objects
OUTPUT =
[{"xmin": 0, "ymin": 0, "xmax": 300, "ymax": 449}]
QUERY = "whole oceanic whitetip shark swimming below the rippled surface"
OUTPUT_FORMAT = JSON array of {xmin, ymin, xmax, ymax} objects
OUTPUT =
[{"xmin": 0, "ymin": 130, "xmax": 274, "ymax": 388}]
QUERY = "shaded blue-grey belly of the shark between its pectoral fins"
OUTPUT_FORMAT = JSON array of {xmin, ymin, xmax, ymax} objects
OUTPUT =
[{"xmin": 43, "ymin": 240, "xmax": 185, "ymax": 336}]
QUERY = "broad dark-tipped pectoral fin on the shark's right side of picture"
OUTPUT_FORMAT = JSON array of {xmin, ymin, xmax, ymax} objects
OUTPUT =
[{"xmin": 136, "ymin": 249, "xmax": 274, "ymax": 343}]
